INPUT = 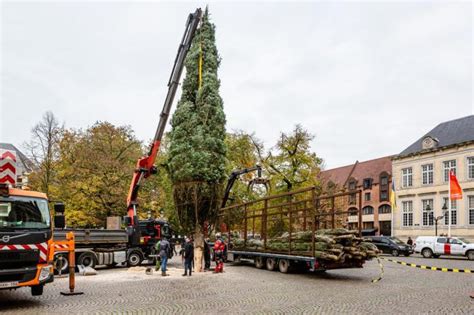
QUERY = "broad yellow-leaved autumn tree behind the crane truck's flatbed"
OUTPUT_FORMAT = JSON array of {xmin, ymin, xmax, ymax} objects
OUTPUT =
[{"xmin": 53, "ymin": 122, "xmax": 143, "ymax": 227}]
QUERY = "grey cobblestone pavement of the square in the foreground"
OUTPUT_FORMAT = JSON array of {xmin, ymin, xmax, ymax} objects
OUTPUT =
[{"xmin": 0, "ymin": 257, "xmax": 474, "ymax": 314}]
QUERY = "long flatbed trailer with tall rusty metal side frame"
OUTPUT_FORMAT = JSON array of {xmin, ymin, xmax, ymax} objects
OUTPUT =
[{"xmin": 219, "ymin": 187, "xmax": 366, "ymax": 273}]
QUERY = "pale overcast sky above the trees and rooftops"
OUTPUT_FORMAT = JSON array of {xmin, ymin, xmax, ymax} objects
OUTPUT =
[{"xmin": 0, "ymin": 1, "xmax": 474, "ymax": 168}]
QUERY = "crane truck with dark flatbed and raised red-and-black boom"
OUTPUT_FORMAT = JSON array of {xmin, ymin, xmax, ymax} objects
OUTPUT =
[{"xmin": 55, "ymin": 8, "xmax": 202, "ymax": 271}]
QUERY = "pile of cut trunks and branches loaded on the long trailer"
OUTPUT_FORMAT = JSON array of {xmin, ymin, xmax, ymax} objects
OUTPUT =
[{"xmin": 232, "ymin": 229, "xmax": 378, "ymax": 262}]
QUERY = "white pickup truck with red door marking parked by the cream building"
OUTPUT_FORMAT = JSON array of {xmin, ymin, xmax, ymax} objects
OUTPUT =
[{"xmin": 415, "ymin": 236, "xmax": 474, "ymax": 260}]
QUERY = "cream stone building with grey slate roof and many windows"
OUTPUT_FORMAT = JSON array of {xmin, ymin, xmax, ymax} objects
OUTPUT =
[{"xmin": 392, "ymin": 115, "xmax": 474, "ymax": 239}]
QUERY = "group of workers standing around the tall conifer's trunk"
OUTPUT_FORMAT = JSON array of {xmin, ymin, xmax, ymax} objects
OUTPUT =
[{"xmin": 155, "ymin": 233, "xmax": 226, "ymax": 277}]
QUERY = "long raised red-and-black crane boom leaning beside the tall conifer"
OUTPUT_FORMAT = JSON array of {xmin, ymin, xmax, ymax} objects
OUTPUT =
[{"xmin": 127, "ymin": 8, "xmax": 202, "ymax": 242}]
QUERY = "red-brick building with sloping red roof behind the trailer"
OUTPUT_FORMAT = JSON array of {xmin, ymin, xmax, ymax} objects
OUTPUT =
[{"xmin": 320, "ymin": 156, "xmax": 392, "ymax": 235}]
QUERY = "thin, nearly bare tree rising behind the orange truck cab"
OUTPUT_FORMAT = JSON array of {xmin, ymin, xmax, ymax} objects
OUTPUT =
[{"xmin": 24, "ymin": 111, "xmax": 64, "ymax": 194}]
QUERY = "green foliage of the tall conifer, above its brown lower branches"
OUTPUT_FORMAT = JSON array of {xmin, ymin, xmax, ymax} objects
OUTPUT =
[{"xmin": 168, "ymin": 10, "xmax": 226, "ymax": 183}]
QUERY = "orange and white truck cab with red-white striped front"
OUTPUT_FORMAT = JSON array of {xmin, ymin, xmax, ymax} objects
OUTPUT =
[{"xmin": 0, "ymin": 184, "xmax": 54, "ymax": 295}]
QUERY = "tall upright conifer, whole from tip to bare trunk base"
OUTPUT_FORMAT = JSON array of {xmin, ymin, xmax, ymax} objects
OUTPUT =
[{"xmin": 168, "ymin": 8, "xmax": 226, "ymax": 270}]
